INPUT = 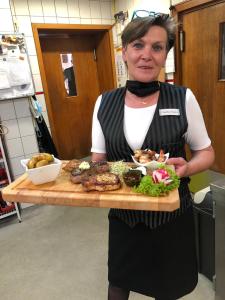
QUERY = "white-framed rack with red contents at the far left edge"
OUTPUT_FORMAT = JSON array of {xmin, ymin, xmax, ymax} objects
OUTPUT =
[{"xmin": 0, "ymin": 134, "xmax": 21, "ymax": 222}]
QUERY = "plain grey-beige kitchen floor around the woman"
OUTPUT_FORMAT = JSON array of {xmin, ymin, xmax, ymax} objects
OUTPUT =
[{"xmin": 0, "ymin": 206, "xmax": 214, "ymax": 300}]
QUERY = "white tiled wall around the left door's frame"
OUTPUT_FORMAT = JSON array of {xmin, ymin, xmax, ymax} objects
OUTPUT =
[{"xmin": 0, "ymin": 0, "xmax": 113, "ymax": 184}]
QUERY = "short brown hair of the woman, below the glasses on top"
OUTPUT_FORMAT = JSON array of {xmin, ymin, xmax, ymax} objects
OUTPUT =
[{"xmin": 121, "ymin": 15, "xmax": 176, "ymax": 51}]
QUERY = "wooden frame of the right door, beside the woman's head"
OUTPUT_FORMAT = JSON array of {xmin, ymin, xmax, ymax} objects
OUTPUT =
[{"xmin": 170, "ymin": 0, "xmax": 225, "ymax": 85}]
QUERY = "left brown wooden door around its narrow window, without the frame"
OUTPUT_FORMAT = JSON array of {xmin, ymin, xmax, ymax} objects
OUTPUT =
[{"xmin": 40, "ymin": 34, "xmax": 100, "ymax": 159}]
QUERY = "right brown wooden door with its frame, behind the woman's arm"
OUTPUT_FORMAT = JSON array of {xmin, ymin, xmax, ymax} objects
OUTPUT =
[{"xmin": 173, "ymin": 1, "xmax": 225, "ymax": 173}]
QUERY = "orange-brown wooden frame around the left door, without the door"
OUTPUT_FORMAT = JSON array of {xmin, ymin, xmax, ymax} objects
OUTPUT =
[{"xmin": 32, "ymin": 23, "xmax": 117, "ymax": 152}]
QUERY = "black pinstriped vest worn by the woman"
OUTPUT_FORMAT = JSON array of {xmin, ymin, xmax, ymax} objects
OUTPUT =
[{"xmin": 98, "ymin": 83, "xmax": 191, "ymax": 228}]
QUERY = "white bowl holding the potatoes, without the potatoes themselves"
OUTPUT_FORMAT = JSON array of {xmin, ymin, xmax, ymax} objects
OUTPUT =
[{"xmin": 21, "ymin": 156, "xmax": 62, "ymax": 185}]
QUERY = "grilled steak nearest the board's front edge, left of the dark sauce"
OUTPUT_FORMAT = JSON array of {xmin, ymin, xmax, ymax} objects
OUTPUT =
[{"xmin": 82, "ymin": 172, "xmax": 121, "ymax": 191}]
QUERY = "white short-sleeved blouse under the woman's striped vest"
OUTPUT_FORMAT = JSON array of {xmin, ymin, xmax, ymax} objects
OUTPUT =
[{"xmin": 91, "ymin": 89, "xmax": 211, "ymax": 153}]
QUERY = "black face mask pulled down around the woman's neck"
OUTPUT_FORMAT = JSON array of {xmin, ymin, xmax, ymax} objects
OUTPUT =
[{"xmin": 126, "ymin": 80, "xmax": 160, "ymax": 97}]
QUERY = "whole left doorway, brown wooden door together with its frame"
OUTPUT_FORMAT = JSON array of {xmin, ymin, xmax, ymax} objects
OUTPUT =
[{"xmin": 33, "ymin": 24, "xmax": 116, "ymax": 159}]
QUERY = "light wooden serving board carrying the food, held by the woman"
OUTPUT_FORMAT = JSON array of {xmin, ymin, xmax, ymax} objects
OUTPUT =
[{"xmin": 2, "ymin": 164, "xmax": 180, "ymax": 211}]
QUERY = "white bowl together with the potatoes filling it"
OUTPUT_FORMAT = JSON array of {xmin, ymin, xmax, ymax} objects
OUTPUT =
[{"xmin": 21, "ymin": 153, "xmax": 62, "ymax": 185}]
